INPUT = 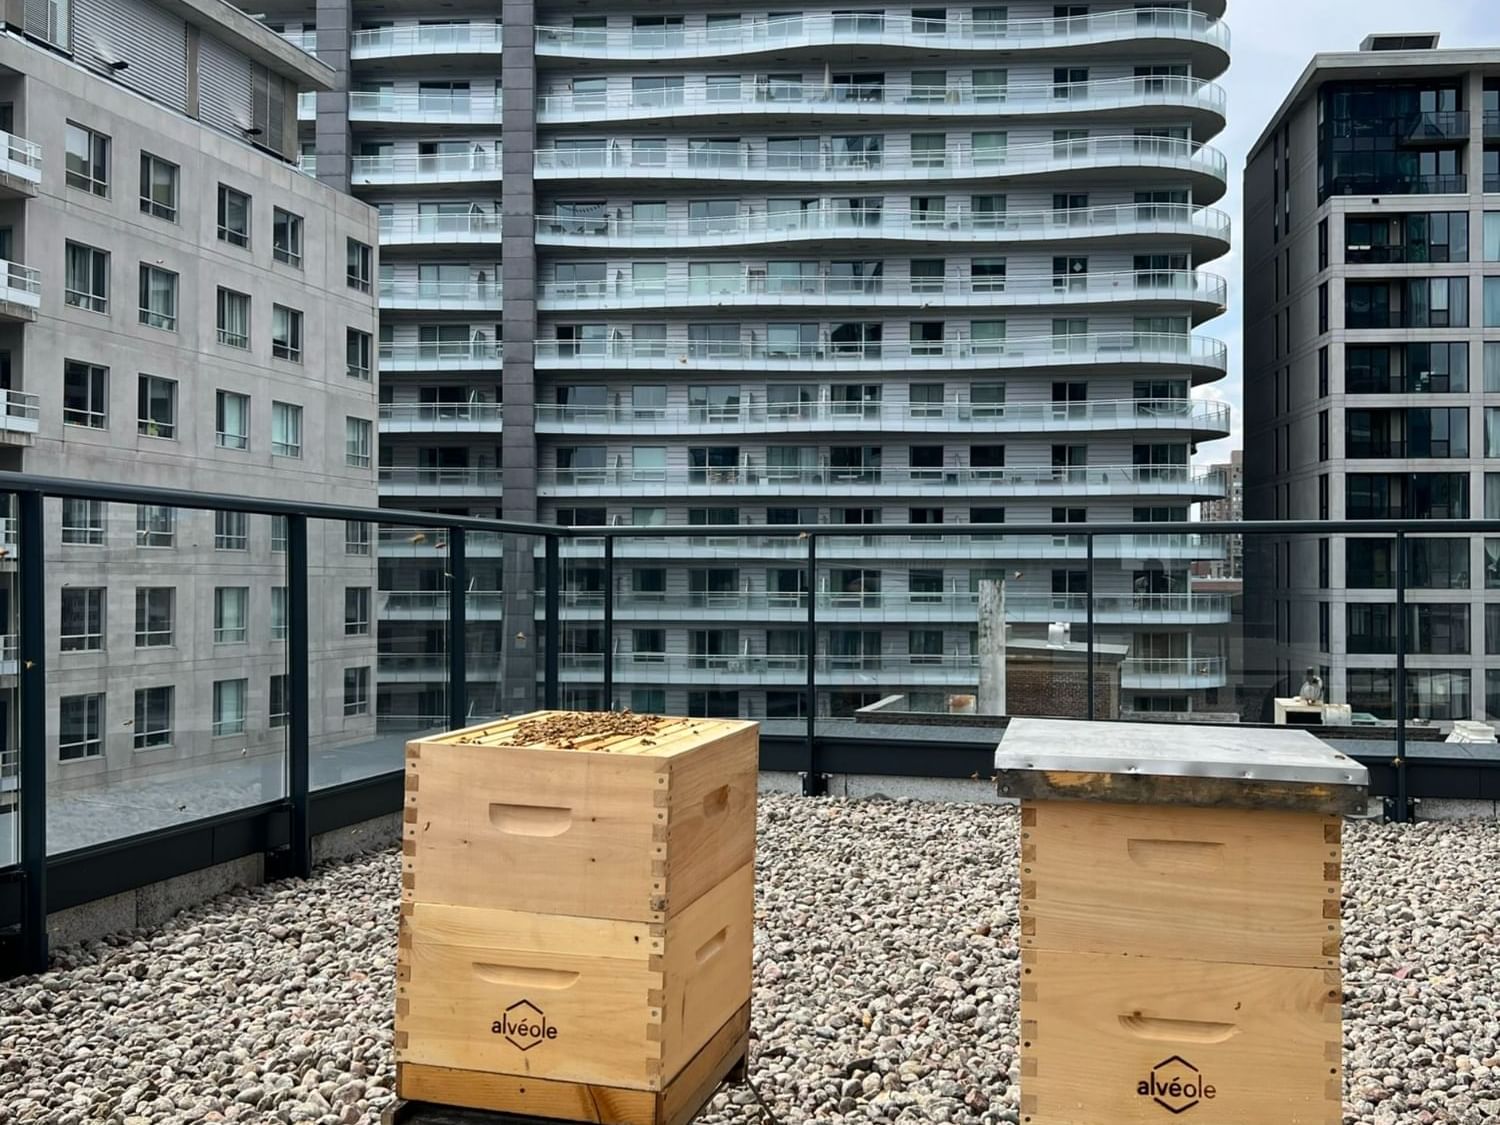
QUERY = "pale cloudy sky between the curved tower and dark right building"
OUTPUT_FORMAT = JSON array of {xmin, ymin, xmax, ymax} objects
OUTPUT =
[{"xmin": 1199, "ymin": 0, "xmax": 1500, "ymax": 462}]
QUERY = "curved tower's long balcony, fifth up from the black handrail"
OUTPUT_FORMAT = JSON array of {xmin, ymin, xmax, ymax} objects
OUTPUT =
[{"xmin": 537, "ymin": 200, "xmax": 1230, "ymax": 264}]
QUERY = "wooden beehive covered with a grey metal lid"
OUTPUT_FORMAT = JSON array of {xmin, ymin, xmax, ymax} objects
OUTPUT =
[{"xmin": 996, "ymin": 720, "xmax": 1367, "ymax": 1125}]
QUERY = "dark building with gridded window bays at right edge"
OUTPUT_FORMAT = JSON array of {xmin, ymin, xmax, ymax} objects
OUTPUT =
[{"xmin": 1245, "ymin": 35, "xmax": 1500, "ymax": 720}]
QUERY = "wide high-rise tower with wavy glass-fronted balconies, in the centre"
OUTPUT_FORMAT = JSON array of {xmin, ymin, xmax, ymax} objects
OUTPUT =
[{"xmin": 279, "ymin": 0, "xmax": 1230, "ymax": 717}]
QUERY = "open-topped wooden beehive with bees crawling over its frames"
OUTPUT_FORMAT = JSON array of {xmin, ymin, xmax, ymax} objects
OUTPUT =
[{"xmin": 396, "ymin": 711, "xmax": 759, "ymax": 1125}]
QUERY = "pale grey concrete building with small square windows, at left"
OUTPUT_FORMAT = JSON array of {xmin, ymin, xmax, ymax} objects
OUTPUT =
[{"xmin": 0, "ymin": 0, "xmax": 377, "ymax": 810}]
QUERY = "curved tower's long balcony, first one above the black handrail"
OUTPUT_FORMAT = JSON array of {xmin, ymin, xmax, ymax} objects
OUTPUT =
[{"xmin": 540, "ymin": 464, "xmax": 1224, "ymax": 500}]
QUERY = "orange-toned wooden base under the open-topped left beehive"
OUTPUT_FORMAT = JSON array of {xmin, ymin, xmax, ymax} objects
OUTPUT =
[{"xmin": 396, "ymin": 1004, "xmax": 750, "ymax": 1125}]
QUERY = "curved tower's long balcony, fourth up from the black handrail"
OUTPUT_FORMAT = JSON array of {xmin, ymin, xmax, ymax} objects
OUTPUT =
[{"xmin": 537, "ymin": 269, "xmax": 1229, "ymax": 321}]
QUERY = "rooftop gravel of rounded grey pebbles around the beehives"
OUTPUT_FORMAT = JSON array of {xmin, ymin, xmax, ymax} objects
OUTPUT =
[{"xmin": 0, "ymin": 795, "xmax": 1500, "ymax": 1125}]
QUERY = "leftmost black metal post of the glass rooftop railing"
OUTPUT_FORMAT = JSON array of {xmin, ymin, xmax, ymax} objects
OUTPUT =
[{"xmin": 17, "ymin": 492, "xmax": 47, "ymax": 974}]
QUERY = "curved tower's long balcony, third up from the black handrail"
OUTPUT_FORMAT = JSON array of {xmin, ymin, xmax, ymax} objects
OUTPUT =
[{"xmin": 534, "ymin": 330, "xmax": 1229, "ymax": 383}]
